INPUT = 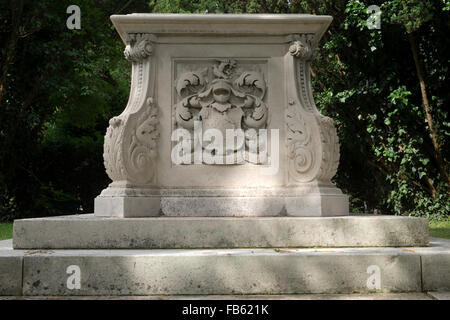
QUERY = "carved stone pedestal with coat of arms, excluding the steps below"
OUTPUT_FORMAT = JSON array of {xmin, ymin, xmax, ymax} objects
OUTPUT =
[{"xmin": 95, "ymin": 14, "xmax": 349, "ymax": 217}]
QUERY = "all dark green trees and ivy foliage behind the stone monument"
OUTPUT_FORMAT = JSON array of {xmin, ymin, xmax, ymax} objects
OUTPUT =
[{"xmin": 0, "ymin": 0, "xmax": 450, "ymax": 219}]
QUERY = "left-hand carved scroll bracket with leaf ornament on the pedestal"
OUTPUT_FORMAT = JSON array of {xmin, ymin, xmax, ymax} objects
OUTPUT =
[{"xmin": 103, "ymin": 33, "xmax": 159, "ymax": 186}]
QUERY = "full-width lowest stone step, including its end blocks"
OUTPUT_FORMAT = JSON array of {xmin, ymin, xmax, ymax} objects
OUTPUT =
[{"xmin": 0, "ymin": 239, "xmax": 450, "ymax": 296}]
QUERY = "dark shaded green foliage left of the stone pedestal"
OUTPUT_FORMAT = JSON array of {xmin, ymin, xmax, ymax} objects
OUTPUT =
[{"xmin": 0, "ymin": 0, "xmax": 147, "ymax": 220}]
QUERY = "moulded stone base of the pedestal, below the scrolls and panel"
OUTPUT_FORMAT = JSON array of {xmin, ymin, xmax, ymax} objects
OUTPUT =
[{"xmin": 94, "ymin": 182, "xmax": 349, "ymax": 217}]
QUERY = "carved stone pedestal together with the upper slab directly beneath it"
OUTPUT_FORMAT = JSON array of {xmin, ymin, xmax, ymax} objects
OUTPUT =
[{"xmin": 14, "ymin": 14, "xmax": 428, "ymax": 248}]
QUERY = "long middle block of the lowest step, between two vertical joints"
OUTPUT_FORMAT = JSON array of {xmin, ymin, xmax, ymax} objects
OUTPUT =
[{"xmin": 23, "ymin": 249, "xmax": 421, "ymax": 295}]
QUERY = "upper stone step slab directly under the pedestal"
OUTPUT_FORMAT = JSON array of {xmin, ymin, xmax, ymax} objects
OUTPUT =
[{"xmin": 13, "ymin": 215, "xmax": 429, "ymax": 249}]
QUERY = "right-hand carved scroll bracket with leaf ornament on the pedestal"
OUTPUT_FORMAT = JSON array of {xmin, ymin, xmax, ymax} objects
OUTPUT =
[{"xmin": 286, "ymin": 34, "xmax": 339, "ymax": 183}]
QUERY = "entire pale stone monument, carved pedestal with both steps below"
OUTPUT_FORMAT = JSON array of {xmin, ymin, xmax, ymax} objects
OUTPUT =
[{"xmin": 0, "ymin": 14, "xmax": 436, "ymax": 295}]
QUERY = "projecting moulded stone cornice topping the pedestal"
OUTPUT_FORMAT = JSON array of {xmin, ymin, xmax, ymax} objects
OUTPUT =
[{"xmin": 111, "ymin": 13, "xmax": 333, "ymax": 43}]
